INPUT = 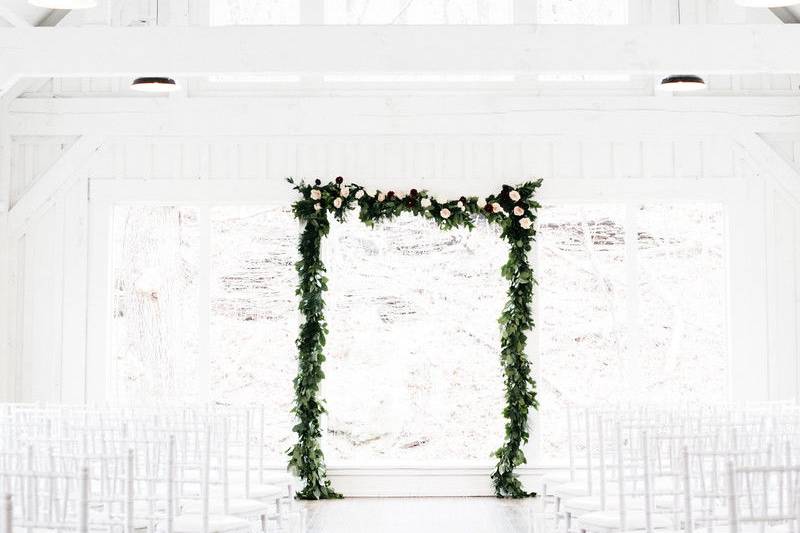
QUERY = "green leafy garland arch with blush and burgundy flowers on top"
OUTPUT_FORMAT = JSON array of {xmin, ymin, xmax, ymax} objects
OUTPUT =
[{"xmin": 287, "ymin": 177, "xmax": 542, "ymax": 500}]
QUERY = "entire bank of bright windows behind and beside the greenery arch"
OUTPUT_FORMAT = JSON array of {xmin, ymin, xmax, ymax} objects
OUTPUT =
[{"xmin": 109, "ymin": 203, "xmax": 728, "ymax": 464}]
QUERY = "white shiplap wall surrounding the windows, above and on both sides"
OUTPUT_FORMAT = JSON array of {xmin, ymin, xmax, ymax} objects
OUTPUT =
[{"xmin": 7, "ymin": 136, "xmax": 800, "ymax": 402}]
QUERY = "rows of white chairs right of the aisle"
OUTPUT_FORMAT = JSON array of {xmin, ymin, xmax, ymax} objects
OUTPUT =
[{"xmin": 543, "ymin": 405, "xmax": 800, "ymax": 533}]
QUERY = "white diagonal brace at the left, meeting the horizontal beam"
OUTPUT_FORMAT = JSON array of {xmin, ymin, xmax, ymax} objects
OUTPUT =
[{"xmin": 8, "ymin": 135, "xmax": 103, "ymax": 228}]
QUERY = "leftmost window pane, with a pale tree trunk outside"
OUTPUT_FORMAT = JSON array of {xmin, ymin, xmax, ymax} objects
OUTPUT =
[{"xmin": 110, "ymin": 206, "xmax": 203, "ymax": 403}]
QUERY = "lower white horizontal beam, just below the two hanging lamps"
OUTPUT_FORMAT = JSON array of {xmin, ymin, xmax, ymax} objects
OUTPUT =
[{"xmin": 8, "ymin": 95, "xmax": 800, "ymax": 137}]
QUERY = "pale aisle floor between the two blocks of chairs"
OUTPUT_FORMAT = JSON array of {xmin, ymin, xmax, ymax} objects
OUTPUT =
[{"xmin": 304, "ymin": 498, "xmax": 544, "ymax": 533}]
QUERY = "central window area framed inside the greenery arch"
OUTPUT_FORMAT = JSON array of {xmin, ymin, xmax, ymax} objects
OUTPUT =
[{"xmin": 323, "ymin": 214, "xmax": 508, "ymax": 463}]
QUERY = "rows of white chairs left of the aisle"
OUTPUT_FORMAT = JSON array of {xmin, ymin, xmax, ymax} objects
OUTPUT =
[{"xmin": 0, "ymin": 404, "xmax": 304, "ymax": 533}]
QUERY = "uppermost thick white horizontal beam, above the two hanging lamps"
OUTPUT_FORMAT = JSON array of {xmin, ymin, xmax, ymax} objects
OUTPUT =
[{"xmin": 0, "ymin": 24, "xmax": 800, "ymax": 85}]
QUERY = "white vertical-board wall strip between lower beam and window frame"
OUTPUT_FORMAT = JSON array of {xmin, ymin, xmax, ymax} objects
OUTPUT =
[{"xmin": 79, "ymin": 136, "xmax": 738, "ymax": 181}]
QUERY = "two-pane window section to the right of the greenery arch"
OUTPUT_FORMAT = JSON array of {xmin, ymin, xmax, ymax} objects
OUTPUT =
[{"xmin": 539, "ymin": 204, "xmax": 728, "ymax": 459}]
